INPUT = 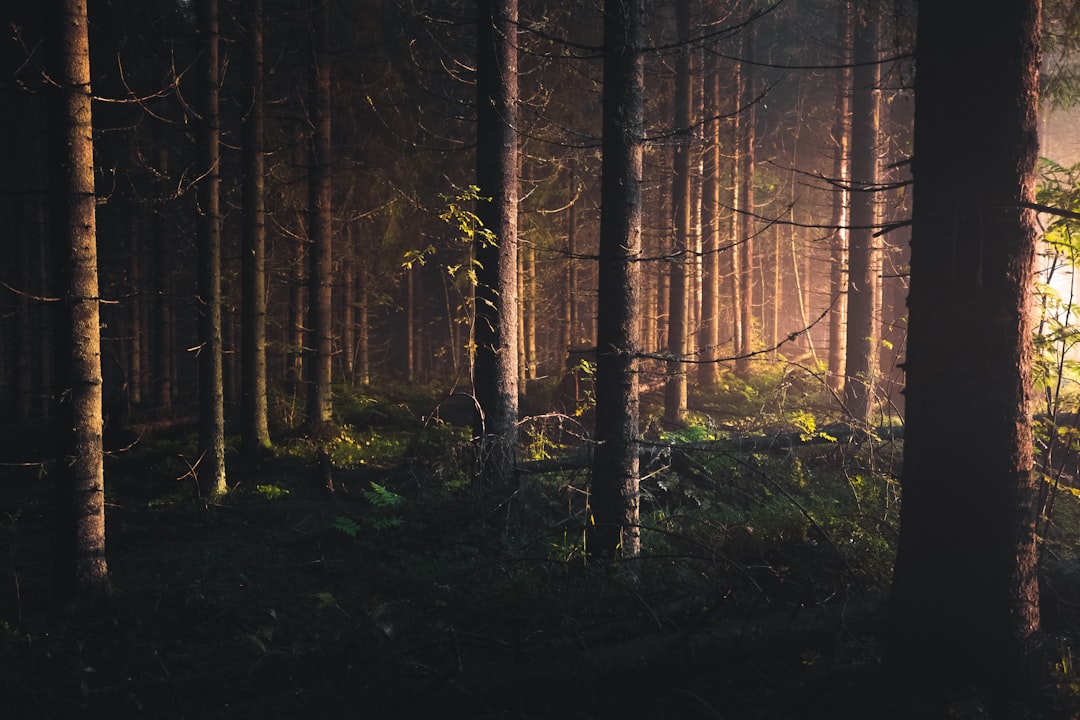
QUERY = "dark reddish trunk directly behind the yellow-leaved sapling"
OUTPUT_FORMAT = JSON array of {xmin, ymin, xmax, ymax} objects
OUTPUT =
[{"xmin": 473, "ymin": 0, "xmax": 518, "ymax": 483}]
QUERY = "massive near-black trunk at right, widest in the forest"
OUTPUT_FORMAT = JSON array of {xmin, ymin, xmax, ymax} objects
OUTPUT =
[{"xmin": 887, "ymin": 0, "xmax": 1041, "ymax": 695}]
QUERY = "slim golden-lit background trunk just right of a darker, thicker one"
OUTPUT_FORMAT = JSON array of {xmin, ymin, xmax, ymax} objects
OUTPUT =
[{"xmin": 698, "ymin": 48, "xmax": 724, "ymax": 386}]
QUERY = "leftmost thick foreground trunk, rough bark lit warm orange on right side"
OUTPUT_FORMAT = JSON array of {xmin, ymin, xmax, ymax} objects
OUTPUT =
[{"xmin": 46, "ymin": 0, "xmax": 108, "ymax": 612}]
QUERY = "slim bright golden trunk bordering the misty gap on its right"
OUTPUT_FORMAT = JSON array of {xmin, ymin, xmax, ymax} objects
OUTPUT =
[{"xmin": 828, "ymin": 2, "xmax": 855, "ymax": 394}]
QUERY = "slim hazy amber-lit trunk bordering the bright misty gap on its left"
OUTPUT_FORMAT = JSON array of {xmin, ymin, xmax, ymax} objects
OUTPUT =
[{"xmin": 735, "ymin": 25, "xmax": 757, "ymax": 377}]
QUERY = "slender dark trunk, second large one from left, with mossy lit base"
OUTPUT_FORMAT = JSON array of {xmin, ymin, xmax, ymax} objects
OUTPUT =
[{"xmin": 198, "ymin": 0, "xmax": 227, "ymax": 498}]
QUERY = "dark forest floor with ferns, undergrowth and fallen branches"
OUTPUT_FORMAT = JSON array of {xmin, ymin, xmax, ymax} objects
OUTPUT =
[{"xmin": 0, "ymin": 382, "xmax": 1080, "ymax": 720}]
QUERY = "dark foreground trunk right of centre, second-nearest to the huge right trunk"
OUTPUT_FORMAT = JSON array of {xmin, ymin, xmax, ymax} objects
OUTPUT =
[{"xmin": 588, "ymin": 0, "xmax": 645, "ymax": 557}]
